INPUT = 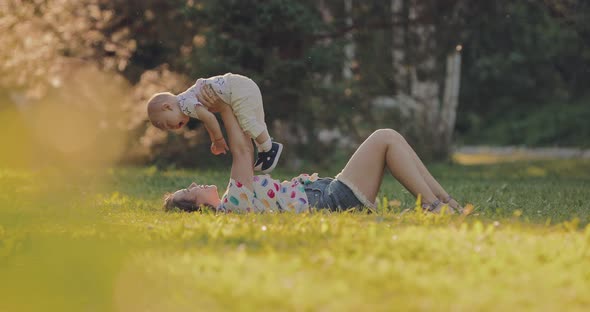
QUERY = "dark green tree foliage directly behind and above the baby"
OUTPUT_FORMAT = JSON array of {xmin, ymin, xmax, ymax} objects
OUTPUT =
[{"xmin": 185, "ymin": 0, "xmax": 342, "ymax": 158}]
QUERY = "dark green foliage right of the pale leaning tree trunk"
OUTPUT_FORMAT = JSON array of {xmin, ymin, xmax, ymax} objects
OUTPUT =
[{"xmin": 457, "ymin": 1, "xmax": 590, "ymax": 141}]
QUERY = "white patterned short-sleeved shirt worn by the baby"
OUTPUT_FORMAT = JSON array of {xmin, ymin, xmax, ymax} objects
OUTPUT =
[{"xmin": 176, "ymin": 73, "xmax": 231, "ymax": 119}]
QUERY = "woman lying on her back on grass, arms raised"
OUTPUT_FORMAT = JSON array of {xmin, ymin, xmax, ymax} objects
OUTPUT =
[{"xmin": 165, "ymin": 87, "xmax": 462, "ymax": 213}]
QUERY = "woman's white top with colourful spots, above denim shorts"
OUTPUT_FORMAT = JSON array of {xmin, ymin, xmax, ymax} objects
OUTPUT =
[{"xmin": 219, "ymin": 173, "xmax": 318, "ymax": 213}]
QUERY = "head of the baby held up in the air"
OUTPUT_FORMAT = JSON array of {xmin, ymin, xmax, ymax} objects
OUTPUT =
[{"xmin": 147, "ymin": 92, "xmax": 189, "ymax": 130}]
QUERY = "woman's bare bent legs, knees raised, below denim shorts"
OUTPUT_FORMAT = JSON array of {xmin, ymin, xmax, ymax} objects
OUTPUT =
[{"xmin": 340, "ymin": 129, "xmax": 437, "ymax": 203}]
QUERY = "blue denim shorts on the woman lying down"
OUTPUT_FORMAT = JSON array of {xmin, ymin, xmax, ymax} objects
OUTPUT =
[{"xmin": 305, "ymin": 178, "xmax": 363, "ymax": 211}]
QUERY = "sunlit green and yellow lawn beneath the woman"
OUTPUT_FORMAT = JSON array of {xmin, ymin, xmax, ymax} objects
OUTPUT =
[{"xmin": 0, "ymin": 160, "xmax": 590, "ymax": 311}]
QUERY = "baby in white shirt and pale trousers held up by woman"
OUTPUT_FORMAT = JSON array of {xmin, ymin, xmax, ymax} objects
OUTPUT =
[{"xmin": 147, "ymin": 73, "xmax": 283, "ymax": 173}]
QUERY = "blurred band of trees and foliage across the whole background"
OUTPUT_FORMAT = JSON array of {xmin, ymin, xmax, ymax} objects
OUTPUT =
[{"xmin": 0, "ymin": 0, "xmax": 590, "ymax": 166}]
